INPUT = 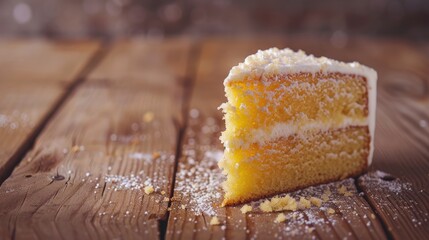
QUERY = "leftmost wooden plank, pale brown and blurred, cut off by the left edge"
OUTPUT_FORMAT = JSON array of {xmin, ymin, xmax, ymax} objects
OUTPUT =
[{"xmin": 0, "ymin": 40, "xmax": 99, "ymax": 183}]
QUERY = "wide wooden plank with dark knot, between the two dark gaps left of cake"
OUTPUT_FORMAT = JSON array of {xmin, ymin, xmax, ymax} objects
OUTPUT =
[{"xmin": 0, "ymin": 38, "xmax": 190, "ymax": 239}]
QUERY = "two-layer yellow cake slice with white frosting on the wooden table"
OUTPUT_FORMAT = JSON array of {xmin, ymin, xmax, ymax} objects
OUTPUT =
[{"xmin": 219, "ymin": 48, "xmax": 377, "ymax": 205}]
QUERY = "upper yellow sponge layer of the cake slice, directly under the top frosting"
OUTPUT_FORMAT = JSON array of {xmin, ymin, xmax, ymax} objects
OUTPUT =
[{"xmin": 222, "ymin": 72, "xmax": 368, "ymax": 146}]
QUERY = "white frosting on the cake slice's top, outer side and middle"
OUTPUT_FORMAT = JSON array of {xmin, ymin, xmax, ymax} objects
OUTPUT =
[{"xmin": 224, "ymin": 48, "xmax": 377, "ymax": 165}]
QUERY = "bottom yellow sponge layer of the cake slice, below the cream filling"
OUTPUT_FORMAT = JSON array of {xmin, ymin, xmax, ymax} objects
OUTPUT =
[{"xmin": 221, "ymin": 126, "xmax": 370, "ymax": 205}]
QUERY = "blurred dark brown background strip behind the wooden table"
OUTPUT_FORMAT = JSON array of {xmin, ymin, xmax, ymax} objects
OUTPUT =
[{"xmin": 0, "ymin": 0, "xmax": 429, "ymax": 42}]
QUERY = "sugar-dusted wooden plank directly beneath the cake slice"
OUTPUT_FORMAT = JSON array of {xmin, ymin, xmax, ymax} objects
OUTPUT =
[{"xmin": 167, "ymin": 36, "xmax": 386, "ymax": 239}]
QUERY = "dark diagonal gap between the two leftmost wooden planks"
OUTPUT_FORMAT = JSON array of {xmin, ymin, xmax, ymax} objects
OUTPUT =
[{"xmin": 0, "ymin": 42, "xmax": 109, "ymax": 186}]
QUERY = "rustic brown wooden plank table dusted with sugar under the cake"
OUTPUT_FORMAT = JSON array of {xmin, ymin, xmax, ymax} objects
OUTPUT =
[{"xmin": 0, "ymin": 36, "xmax": 429, "ymax": 239}]
